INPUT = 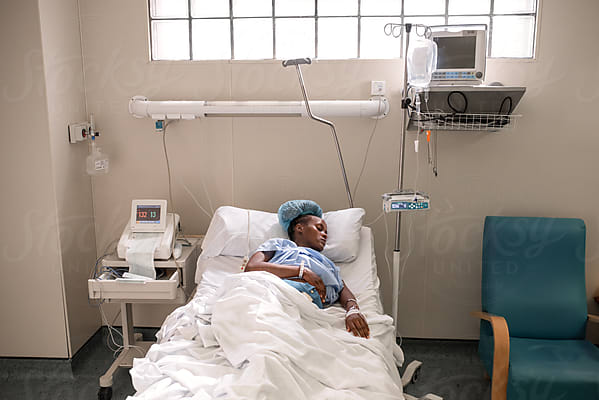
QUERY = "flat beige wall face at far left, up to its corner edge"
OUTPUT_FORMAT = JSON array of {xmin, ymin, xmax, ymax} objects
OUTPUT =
[{"xmin": 0, "ymin": 0, "xmax": 68, "ymax": 357}]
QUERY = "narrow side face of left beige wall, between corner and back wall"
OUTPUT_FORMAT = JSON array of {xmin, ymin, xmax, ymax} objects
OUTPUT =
[{"xmin": 40, "ymin": 0, "xmax": 100, "ymax": 356}]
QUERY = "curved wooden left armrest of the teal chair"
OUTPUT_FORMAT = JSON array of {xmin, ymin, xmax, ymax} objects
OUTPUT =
[{"xmin": 470, "ymin": 311, "xmax": 510, "ymax": 400}]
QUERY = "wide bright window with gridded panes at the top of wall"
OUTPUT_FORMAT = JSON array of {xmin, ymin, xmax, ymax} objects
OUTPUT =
[{"xmin": 148, "ymin": 0, "xmax": 539, "ymax": 60}]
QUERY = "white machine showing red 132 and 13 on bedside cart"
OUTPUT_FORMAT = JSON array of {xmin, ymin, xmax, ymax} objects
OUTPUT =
[{"xmin": 117, "ymin": 200, "xmax": 181, "ymax": 260}]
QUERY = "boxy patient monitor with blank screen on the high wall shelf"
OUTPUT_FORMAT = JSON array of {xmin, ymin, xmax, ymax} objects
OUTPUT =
[{"xmin": 431, "ymin": 25, "xmax": 487, "ymax": 85}]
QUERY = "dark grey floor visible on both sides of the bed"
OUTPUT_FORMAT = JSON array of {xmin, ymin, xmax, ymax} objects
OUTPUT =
[{"xmin": 0, "ymin": 329, "xmax": 490, "ymax": 400}]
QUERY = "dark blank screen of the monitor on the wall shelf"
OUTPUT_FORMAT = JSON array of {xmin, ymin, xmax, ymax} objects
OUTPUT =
[{"xmin": 433, "ymin": 36, "xmax": 476, "ymax": 69}]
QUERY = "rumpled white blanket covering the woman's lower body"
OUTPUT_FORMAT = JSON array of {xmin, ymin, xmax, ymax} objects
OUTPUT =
[{"xmin": 131, "ymin": 272, "xmax": 403, "ymax": 400}]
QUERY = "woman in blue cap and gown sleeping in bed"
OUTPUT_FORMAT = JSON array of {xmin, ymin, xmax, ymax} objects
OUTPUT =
[{"xmin": 245, "ymin": 200, "xmax": 370, "ymax": 338}]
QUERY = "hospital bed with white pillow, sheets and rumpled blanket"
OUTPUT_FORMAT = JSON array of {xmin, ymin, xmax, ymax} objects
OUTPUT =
[{"xmin": 124, "ymin": 207, "xmax": 438, "ymax": 400}]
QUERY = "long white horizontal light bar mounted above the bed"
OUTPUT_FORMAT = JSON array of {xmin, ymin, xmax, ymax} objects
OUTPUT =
[{"xmin": 129, "ymin": 96, "xmax": 389, "ymax": 120}]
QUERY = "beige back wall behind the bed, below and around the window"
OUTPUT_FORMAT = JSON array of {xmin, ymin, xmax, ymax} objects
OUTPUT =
[{"xmin": 81, "ymin": 0, "xmax": 599, "ymax": 338}]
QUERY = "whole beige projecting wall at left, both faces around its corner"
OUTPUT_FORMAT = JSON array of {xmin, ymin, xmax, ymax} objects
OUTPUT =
[{"xmin": 0, "ymin": 0, "xmax": 100, "ymax": 358}]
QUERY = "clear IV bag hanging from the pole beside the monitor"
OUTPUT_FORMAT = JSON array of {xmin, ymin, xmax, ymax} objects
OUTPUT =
[{"xmin": 408, "ymin": 36, "xmax": 437, "ymax": 87}]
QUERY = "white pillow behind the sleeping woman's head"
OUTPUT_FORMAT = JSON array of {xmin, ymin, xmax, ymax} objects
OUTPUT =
[{"xmin": 202, "ymin": 206, "xmax": 365, "ymax": 262}]
